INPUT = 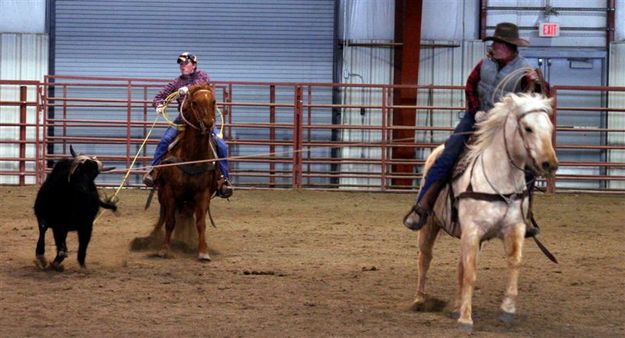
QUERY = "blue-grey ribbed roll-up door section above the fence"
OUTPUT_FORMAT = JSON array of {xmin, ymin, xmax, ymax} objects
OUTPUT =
[{"xmin": 54, "ymin": 0, "xmax": 335, "ymax": 82}]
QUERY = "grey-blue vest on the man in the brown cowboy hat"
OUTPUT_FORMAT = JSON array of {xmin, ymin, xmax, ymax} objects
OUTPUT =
[{"xmin": 477, "ymin": 55, "xmax": 530, "ymax": 111}]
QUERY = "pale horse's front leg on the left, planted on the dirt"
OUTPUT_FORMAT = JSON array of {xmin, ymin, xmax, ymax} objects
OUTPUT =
[{"xmin": 458, "ymin": 228, "xmax": 480, "ymax": 332}]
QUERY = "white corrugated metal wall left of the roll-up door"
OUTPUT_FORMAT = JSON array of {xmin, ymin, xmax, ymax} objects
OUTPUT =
[{"xmin": 0, "ymin": 33, "xmax": 48, "ymax": 184}]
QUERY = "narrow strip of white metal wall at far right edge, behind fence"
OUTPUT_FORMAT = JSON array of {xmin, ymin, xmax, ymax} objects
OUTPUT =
[{"xmin": 607, "ymin": 41, "xmax": 625, "ymax": 189}]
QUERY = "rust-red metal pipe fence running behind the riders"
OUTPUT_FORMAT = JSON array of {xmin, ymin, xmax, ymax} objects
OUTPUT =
[{"xmin": 0, "ymin": 76, "xmax": 625, "ymax": 192}]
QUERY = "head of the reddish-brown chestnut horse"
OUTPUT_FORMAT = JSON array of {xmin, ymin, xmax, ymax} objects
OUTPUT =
[{"xmin": 180, "ymin": 84, "xmax": 215, "ymax": 134}]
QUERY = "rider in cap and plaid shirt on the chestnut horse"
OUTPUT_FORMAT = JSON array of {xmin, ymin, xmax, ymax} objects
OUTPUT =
[{"xmin": 143, "ymin": 52, "xmax": 233, "ymax": 198}]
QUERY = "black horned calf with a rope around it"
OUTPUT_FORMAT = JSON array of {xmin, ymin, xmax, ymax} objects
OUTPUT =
[{"xmin": 35, "ymin": 146, "xmax": 117, "ymax": 271}]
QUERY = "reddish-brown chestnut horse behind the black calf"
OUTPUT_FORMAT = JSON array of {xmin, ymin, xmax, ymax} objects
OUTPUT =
[{"xmin": 155, "ymin": 85, "xmax": 217, "ymax": 261}]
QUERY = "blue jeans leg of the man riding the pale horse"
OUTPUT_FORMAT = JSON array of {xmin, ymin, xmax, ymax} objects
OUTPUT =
[{"xmin": 417, "ymin": 112, "xmax": 475, "ymax": 203}]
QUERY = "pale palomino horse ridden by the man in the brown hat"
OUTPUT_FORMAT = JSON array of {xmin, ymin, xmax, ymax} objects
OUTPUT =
[{"xmin": 413, "ymin": 94, "xmax": 558, "ymax": 332}]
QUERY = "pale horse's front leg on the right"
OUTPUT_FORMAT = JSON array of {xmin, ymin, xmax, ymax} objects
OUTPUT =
[{"xmin": 499, "ymin": 223, "xmax": 525, "ymax": 323}]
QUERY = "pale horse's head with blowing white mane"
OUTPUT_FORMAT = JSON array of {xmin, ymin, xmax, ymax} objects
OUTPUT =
[{"xmin": 468, "ymin": 93, "xmax": 558, "ymax": 177}]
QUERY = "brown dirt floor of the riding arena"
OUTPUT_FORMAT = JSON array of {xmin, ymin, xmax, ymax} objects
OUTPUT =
[{"xmin": 0, "ymin": 186, "xmax": 625, "ymax": 337}]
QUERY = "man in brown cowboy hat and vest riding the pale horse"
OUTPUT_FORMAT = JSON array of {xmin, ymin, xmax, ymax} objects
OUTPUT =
[{"xmin": 404, "ymin": 22, "xmax": 548, "ymax": 236}]
